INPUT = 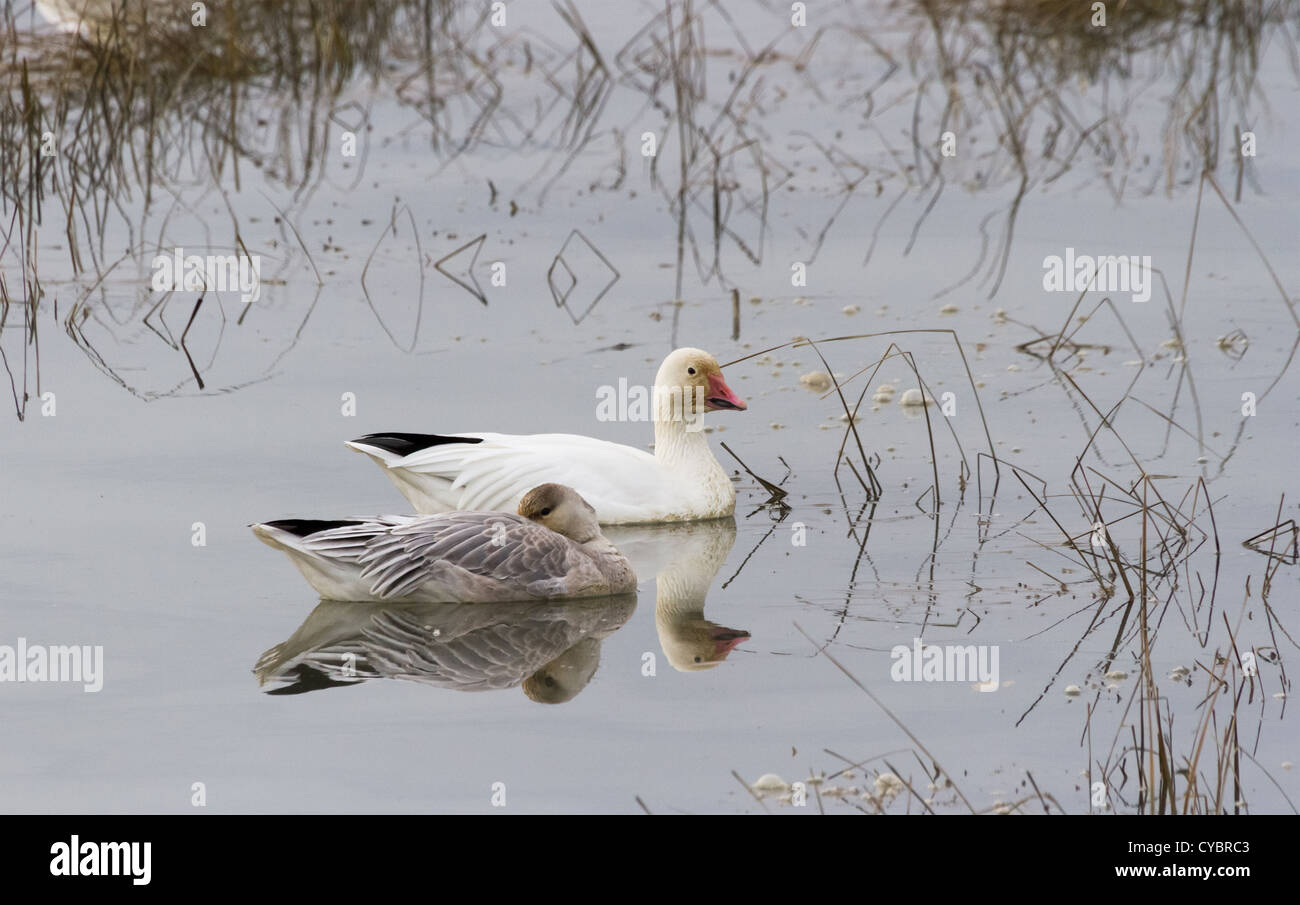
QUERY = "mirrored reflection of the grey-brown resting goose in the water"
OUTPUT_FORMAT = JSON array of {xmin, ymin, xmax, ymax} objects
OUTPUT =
[{"xmin": 254, "ymin": 594, "xmax": 637, "ymax": 703}]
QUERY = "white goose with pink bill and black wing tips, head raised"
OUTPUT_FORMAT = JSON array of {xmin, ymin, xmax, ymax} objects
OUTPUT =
[{"xmin": 348, "ymin": 348, "xmax": 746, "ymax": 524}]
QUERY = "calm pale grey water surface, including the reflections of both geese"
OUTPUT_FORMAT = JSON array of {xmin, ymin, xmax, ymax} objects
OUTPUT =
[{"xmin": 0, "ymin": 3, "xmax": 1300, "ymax": 813}]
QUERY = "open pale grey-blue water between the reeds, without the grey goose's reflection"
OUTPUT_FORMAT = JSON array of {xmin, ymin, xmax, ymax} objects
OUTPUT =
[{"xmin": 0, "ymin": 3, "xmax": 1300, "ymax": 813}]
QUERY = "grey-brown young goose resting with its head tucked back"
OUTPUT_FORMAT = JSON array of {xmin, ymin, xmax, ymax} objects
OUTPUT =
[{"xmin": 251, "ymin": 484, "xmax": 637, "ymax": 603}]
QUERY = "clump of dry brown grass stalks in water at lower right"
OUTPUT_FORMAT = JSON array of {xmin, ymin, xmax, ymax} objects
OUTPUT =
[{"xmin": 993, "ymin": 173, "xmax": 1300, "ymax": 814}]
